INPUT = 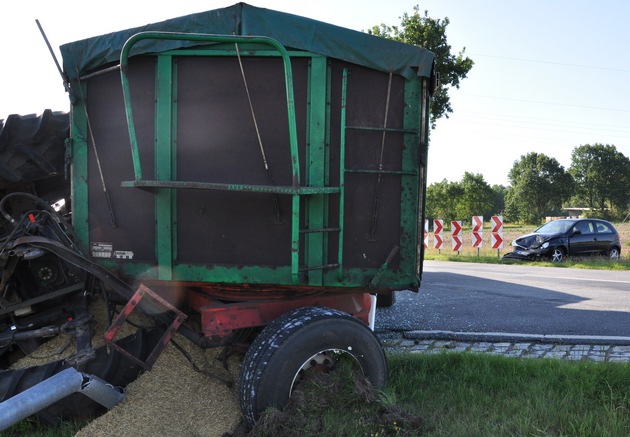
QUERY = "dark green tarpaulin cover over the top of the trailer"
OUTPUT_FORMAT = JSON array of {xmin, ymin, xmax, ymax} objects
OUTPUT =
[{"xmin": 60, "ymin": 3, "xmax": 434, "ymax": 79}]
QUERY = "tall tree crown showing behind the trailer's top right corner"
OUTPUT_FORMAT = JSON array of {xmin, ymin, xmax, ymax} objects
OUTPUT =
[{"xmin": 368, "ymin": 5, "xmax": 474, "ymax": 128}]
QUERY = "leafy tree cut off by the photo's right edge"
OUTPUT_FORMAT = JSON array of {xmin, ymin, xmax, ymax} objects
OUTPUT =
[{"xmin": 569, "ymin": 144, "xmax": 630, "ymax": 218}]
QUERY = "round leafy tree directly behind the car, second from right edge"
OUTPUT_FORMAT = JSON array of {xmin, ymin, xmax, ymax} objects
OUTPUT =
[{"xmin": 506, "ymin": 152, "xmax": 574, "ymax": 223}]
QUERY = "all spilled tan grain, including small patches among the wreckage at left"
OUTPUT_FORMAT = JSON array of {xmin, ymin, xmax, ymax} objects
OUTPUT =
[{"xmin": 12, "ymin": 299, "xmax": 247, "ymax": 437}]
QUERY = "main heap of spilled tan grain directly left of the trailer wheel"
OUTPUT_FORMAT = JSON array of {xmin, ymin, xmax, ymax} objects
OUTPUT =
[{"xmin": 76, "ymin": 337, "xmax": 241, "ymax": 437}]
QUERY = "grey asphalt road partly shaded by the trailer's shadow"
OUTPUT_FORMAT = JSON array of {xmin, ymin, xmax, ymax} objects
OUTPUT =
[{"xmin": 375, "ymin": 261, "xmax": 630, "ymax": 337}]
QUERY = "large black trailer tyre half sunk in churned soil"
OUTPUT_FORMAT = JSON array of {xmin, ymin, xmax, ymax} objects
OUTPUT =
[{"xmin": 238, "ymin": 307, "xmax": 387, "ymax": 425}]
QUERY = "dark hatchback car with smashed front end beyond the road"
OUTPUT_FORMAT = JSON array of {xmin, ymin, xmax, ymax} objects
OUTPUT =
[{"xmin": 503, "ymin": 219, "xmax": 621, "ymax": 262}]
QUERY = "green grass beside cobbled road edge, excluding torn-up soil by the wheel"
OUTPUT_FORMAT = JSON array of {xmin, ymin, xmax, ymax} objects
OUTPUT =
[{"xmin": 385, "ymin": 353, "xmax": 630, "ymax": 437}]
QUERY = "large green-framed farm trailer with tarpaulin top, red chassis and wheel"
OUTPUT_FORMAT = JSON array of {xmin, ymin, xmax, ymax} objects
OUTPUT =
[{"xmin": 0, "ymin": 3, "xmax": 436, "ymax": 422}]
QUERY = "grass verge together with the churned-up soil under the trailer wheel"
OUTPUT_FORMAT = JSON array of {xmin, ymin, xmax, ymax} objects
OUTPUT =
[{"xmin": 243, "ymin": 352, "xmax": 630, "ymax": 437}]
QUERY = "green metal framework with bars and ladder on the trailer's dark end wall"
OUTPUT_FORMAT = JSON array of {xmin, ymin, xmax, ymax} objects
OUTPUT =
[{"xmin": 72, "ymin": 32, "xmax": 428, "ymax": 289}]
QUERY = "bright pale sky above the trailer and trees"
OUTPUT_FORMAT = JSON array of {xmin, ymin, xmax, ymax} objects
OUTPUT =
[{"xmin": 0, "ymin": 0, "xmax": 630, "ymax": 186}]
